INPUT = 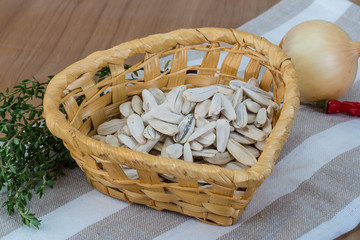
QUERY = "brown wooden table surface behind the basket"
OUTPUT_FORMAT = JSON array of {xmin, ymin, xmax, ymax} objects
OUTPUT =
[{"xmin": 0, "ymin": 0, "xmax": 360, "ymax": 240}]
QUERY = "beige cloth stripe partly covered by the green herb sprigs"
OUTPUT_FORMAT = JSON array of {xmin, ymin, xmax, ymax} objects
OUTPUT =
[{"xmin": 0, "ymin": 168, "xmax": 93, "ymax": 237}]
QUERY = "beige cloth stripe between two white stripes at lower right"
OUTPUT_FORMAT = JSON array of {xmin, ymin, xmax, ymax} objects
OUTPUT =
[{"xmin": 220, "ymin": 147, "xmax": 360, "ymax": 239}]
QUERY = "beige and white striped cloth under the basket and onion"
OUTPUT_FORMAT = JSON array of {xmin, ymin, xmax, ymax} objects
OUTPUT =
[{"xmin": 0, "ymin": 0, "xmax": 360, "ymax": 240}]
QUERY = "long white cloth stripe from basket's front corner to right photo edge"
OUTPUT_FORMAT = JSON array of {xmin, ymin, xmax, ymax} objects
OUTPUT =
[{"xmin": 156, "ymin": 119, "xmax": 360, "ymax": 240}]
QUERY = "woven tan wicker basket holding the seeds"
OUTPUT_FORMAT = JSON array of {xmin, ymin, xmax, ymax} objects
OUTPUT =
[{"xmin": 44, "ymin": 28, "xmax": 299, "ymax": 225}]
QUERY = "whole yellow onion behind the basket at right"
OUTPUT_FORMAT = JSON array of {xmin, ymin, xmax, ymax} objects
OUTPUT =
[{"xmin": 280, "ymin": 20, "xmax": 360, "ymax": 102}]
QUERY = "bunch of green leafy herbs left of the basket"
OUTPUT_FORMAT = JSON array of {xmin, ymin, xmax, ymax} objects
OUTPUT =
[{"xmin": 0, "ymin": 76, "xmax": 75, "ymax": 228}]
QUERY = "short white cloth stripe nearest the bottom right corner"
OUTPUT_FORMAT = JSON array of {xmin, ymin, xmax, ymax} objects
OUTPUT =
[{"xmin": 299, "ymin": 196, "xmax": 360, "ymax": 240}]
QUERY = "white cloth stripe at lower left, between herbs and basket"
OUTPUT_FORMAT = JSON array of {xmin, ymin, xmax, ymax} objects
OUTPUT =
[{"xmin": 0, "ymin": 190, "xmax": 129, "ymax": 240}]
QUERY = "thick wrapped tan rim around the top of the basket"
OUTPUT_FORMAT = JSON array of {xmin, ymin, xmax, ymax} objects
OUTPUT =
[{"xmin": 44, "ymin": 28, "xmax": 299, "ymax": 186}]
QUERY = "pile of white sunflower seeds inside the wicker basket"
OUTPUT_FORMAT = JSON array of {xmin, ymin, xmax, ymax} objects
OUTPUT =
[{"xmin": 93, "ymin": 78, "xmax": 279, "ymax": 169}]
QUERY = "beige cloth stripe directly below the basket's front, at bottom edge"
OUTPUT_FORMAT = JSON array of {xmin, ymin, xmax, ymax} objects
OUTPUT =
[{"xmin": 70, "ymin": 205, "xmax": 190, "ymax": 240}]
